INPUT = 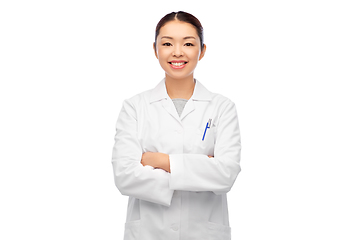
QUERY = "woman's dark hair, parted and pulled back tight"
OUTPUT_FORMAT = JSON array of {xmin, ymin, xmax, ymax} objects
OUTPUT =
[{"xmin": 155, "ymin": 11, "xmax": 204, "ymax": 50}]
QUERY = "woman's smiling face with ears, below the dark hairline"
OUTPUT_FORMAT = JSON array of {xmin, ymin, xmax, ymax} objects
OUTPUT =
[{"xmin": 154, "ymin": 20, "xmax": 206, "ymax": 79}]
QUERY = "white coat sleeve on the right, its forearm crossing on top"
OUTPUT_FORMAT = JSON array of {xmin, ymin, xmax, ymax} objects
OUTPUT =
[{"xmin": 169, "ymin": 100, "xmax": 241, "ymax": 194}]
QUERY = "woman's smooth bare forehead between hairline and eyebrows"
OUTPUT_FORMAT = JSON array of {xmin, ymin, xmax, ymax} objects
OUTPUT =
[{"xmin": 158, "ymin": 21, "xmax": 199, "ymax": 39}]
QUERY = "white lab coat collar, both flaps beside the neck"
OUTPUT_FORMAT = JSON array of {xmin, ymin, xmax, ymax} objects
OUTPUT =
[{"xmin": 150, "ymin": 78, "xmax": 212, "ymax": 103}]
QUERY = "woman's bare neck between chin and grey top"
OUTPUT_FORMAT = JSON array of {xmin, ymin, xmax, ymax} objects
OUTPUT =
[{"xmin": 165, "ymin": 75, "xmax": 195, "ymax": 100}]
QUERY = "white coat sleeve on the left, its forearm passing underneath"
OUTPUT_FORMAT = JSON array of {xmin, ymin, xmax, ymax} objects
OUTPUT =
[{"xmin": 112, "ymin": 100, "xmax": 174, "ymax": 206}]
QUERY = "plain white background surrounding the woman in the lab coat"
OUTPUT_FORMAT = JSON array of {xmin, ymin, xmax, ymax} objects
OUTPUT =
[{"xmin": 0, "ymin": 0, "xmax": 360, "ymax": 240}]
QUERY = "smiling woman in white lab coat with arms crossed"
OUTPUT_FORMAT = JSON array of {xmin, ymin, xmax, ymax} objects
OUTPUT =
[{"xmin": 112, "ymin": 12, "xmax": 241, "ymax": 240}]
